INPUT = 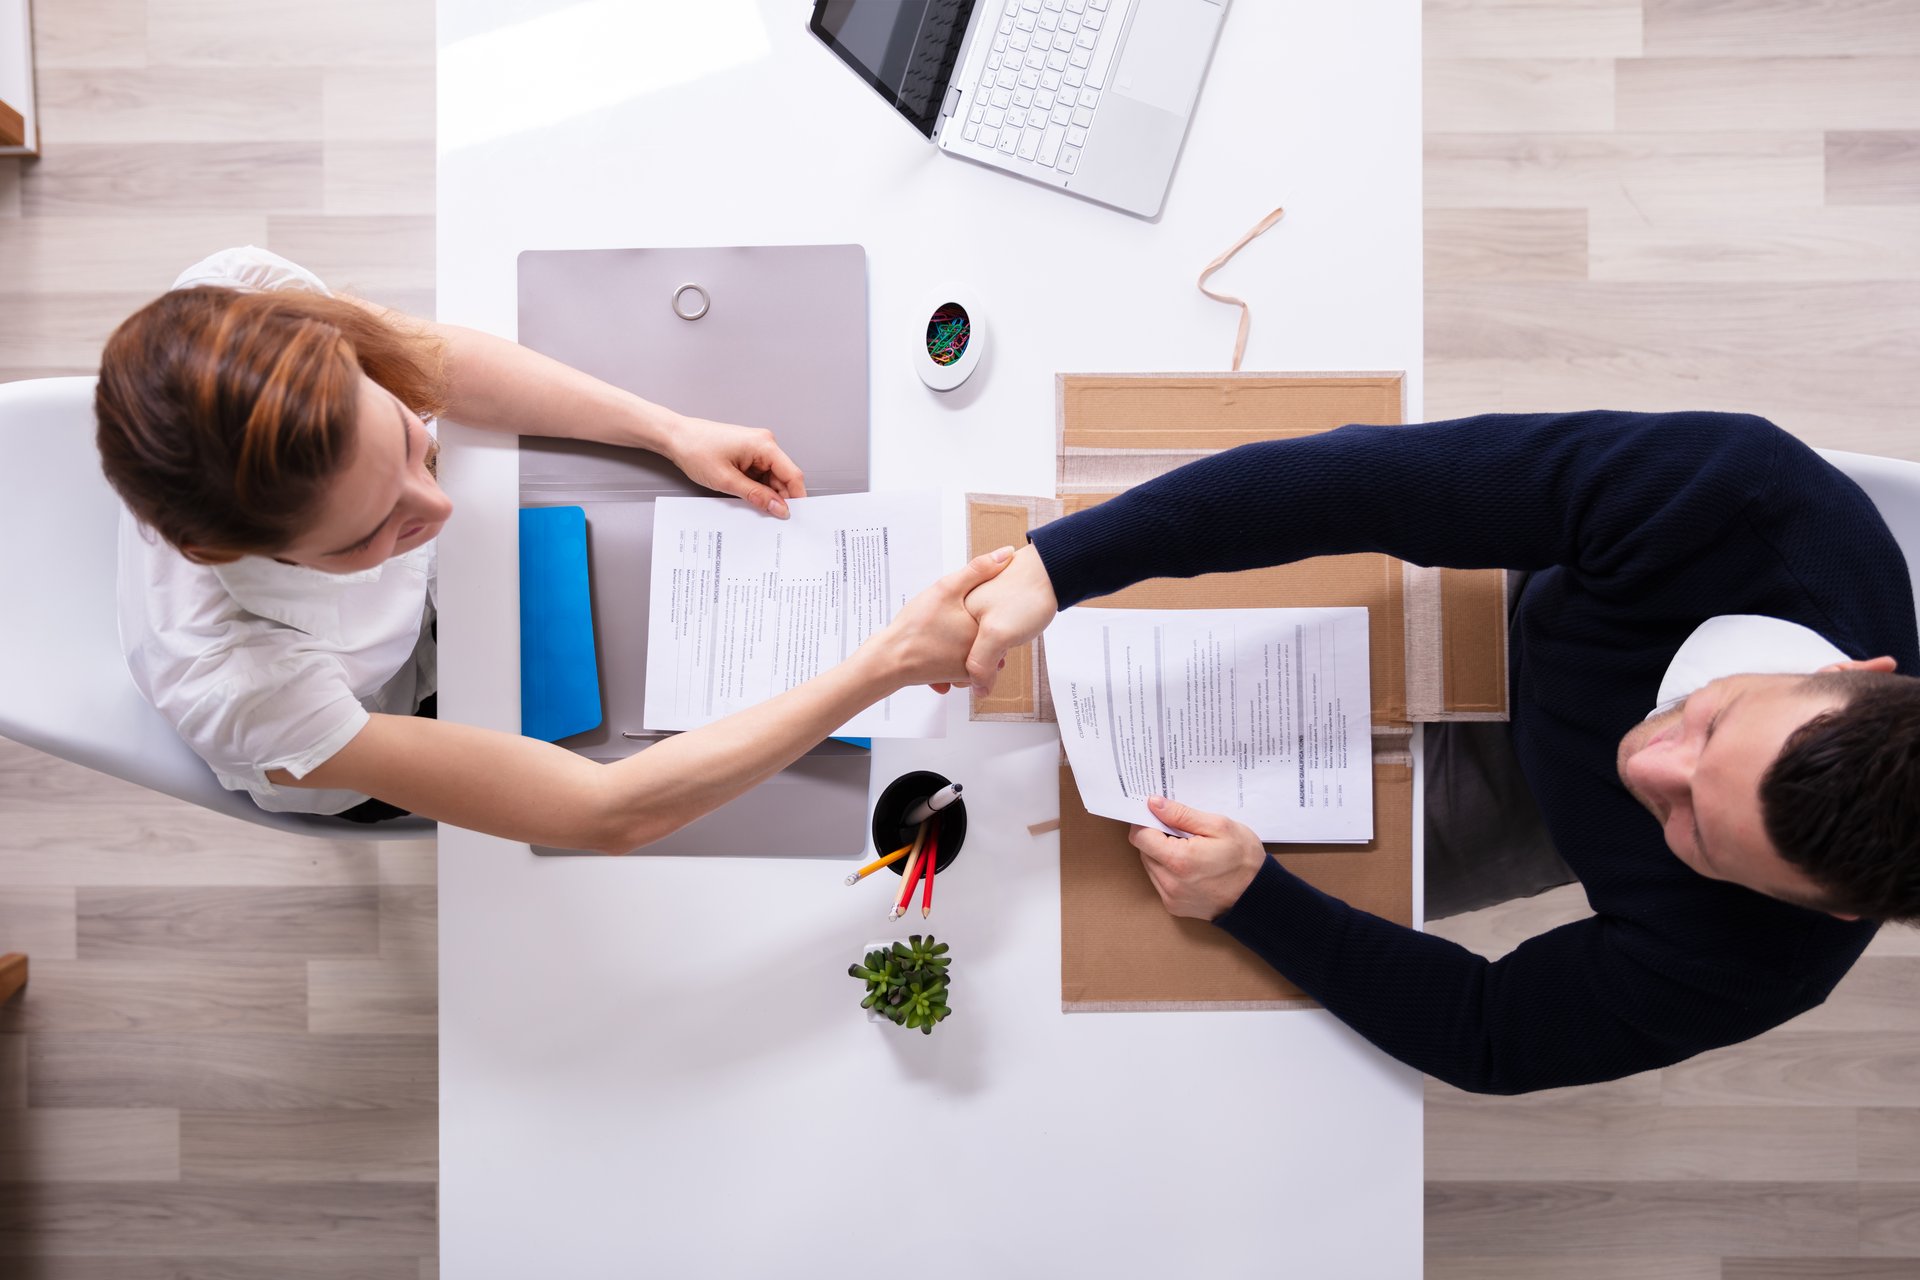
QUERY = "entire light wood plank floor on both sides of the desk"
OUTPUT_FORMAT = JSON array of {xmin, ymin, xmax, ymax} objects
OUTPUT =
[{"xmin": 0, "ymin": 0, "xmax": 1920, "ymax": 1280}]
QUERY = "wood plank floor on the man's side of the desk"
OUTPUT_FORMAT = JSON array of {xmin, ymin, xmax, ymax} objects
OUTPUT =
[{"xmin": 1427, "ymin": 0, "xmax": 1920, "ymax": 1280}]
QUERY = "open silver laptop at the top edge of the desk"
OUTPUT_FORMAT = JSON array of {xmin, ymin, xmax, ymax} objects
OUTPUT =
[{"xmin": 808, "ymin": 0, "xmax": 1227, "ymax": 217}]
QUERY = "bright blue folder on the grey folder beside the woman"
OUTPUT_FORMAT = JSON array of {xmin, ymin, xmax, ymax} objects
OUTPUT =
[{"xmin": 520, "ymin": 507, "xmax": 601, "ymax": 743}]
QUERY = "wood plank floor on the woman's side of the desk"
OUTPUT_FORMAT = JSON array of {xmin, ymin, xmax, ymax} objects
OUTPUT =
[{"xmin": 0, "ymin": 0, "xmax": 438, "ymax": 1280}]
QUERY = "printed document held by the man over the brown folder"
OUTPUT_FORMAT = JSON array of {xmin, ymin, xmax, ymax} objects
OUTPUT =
[{"xmin": 1046, "ymin": 608, "xmax": 1373, "ymax": 842}]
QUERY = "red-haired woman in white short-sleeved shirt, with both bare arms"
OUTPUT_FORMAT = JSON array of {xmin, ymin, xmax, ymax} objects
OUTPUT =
[{"xmin": 96, "ymin": 248, "xmax": 1012, "ymax": 852}]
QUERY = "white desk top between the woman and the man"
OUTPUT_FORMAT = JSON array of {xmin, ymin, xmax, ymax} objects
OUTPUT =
[{"xmin": 438, "ymin": 0, "xmax": 1421, "ymax": 1280}]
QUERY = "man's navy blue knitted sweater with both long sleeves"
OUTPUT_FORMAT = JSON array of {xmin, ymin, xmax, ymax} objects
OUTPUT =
[{"xmin": 1031, "ymin": 413, "xmax": 1920, "ymax": 1094}]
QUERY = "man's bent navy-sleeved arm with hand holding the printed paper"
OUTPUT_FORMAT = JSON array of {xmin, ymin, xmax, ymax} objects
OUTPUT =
[{"xmin": 1131, "ymin": 798, "xmax": 1818, "ymax": 1094}]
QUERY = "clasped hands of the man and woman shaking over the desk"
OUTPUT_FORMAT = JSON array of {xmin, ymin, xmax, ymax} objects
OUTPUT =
[{"xmin": 862, "ymin": 545, "xmax": 1060, "ymax": 693}]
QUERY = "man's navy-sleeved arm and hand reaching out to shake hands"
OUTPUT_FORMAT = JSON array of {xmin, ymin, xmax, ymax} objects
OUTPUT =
[{"xmin": 968, "ymin": 413, "xmax": 1788, "ymax": 691}]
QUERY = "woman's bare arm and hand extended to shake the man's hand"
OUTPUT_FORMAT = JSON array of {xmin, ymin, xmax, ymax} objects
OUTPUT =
[{"xmin": 269, "ymin": 547, "xmax": 1012, "ymax": 854}]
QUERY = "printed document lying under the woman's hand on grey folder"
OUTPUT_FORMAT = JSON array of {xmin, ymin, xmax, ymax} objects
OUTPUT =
[{"xmin": 645, "ymin": 493, "xmax": 947, "ymax": 737}]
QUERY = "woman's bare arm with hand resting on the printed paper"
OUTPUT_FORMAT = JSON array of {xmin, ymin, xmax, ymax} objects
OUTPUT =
[{"xmin": 348, "ymin": 297, "xmax": 806, "ymax": 518}]
